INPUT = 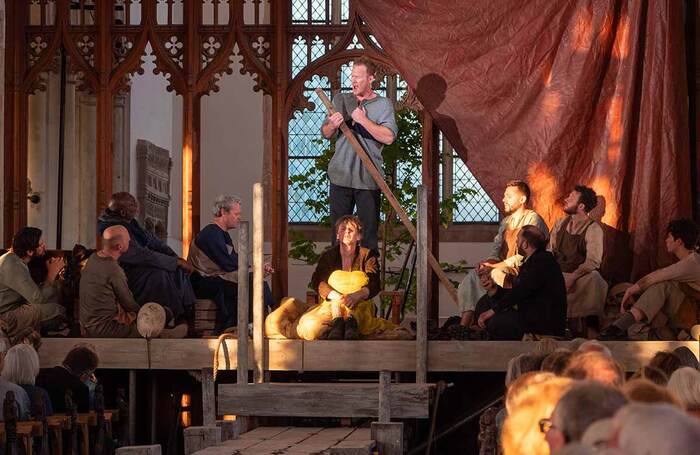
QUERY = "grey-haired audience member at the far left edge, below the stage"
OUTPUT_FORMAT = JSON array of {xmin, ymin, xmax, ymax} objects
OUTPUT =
[{"xmin": 1, "ymin": 343, "xmax": 53, "ymax": 416}]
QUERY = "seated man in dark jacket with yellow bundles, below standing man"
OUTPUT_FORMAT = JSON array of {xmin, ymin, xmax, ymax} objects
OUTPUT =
[{"xmin": 265, "ymin": 215, "xmax": 411, "ymax": 340}]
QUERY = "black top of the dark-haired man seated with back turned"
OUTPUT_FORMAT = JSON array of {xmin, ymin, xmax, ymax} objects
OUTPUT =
[{"xmin": 494, "ymin": 250, "xmax": 566, "ymax": 336}]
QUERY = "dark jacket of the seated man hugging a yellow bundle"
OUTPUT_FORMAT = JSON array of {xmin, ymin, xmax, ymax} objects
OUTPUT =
[{"xmin": 311, "ymin": 244, "xmax": 381, "ymax": 299}]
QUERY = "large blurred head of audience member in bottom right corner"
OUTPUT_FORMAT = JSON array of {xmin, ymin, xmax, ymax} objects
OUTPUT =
[{"xmin": 610, "ymin": 403, "xmax": 700, "ymax": 455}]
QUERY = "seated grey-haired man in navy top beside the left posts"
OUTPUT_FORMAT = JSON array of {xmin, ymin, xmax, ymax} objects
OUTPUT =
[{"xmin": 187, "ymin": 195, "xmax": 275, "ymax": 334}]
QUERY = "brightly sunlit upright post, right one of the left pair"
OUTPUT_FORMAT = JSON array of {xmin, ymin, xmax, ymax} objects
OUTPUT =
[{"xmin": 253, "ymin": 183, "xmax": 267, "ymax": 384}]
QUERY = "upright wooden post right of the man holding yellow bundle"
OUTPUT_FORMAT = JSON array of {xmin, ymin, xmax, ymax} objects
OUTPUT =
[{"xmin": 416, "ymin": 185, "xmax": 428, "ymax": 384}]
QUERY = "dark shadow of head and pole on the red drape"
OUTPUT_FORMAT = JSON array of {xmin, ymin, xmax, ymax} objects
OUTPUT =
[{"xmin": 415, "ymin": 73, "xmax": 467, "ymax": 161}]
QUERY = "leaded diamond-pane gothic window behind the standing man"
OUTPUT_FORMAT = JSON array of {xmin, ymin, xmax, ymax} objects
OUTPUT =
[{"xmin": 288, "ymin": 0, "xmax": 499, "ymax": 224}]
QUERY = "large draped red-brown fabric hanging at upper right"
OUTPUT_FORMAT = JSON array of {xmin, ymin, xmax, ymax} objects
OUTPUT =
[{"xmin": 356, "ymin": 0, "xmax": 691, "ymax": 277}]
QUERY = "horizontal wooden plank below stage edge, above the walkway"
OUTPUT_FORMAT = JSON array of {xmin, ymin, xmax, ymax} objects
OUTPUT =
[{"xmin": 218, "ymin": 383, "xmax": 431, "ymax": 419}]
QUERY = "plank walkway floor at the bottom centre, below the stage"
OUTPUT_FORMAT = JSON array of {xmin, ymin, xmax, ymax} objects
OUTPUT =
[{"xmin": 195, "ymin": 427, "xmax": 370, "ymax": 455}]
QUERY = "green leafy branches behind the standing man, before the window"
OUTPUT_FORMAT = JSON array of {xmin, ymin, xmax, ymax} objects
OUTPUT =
[{"xmin": 289, "ymin": 109, "xmax": 476, "ymax": 308}]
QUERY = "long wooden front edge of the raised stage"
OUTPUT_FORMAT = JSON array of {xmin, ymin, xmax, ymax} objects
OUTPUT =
[{"xmin": 39, "ymin": 338, "xmax": 700, "ymax": 372}]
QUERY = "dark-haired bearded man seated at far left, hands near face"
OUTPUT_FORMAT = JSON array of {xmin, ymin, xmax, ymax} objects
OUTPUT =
[{"xmin": 0, "ymin": 227, "xmax": 66, "ymax": 338}]
